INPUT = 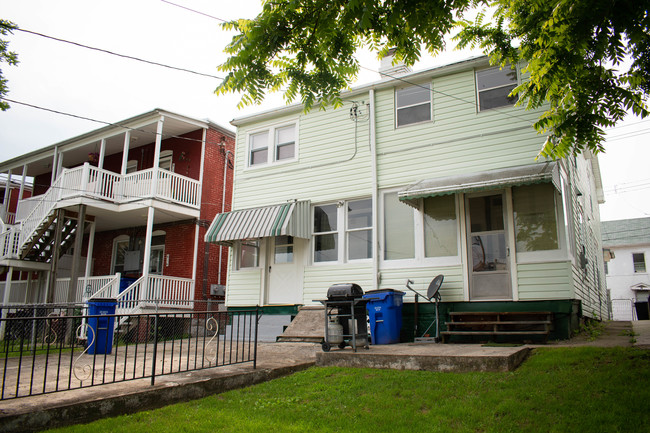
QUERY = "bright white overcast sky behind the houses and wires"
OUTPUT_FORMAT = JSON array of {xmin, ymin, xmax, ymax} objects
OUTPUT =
[{"xmin": 0, "ymin": 0, "xmax": 650, "ymax": 220}]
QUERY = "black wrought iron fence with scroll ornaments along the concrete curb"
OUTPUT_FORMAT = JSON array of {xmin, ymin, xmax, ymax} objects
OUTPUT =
[{"xmin": 0, "ymin": 304, "xmax": 260, "ymax": 400}]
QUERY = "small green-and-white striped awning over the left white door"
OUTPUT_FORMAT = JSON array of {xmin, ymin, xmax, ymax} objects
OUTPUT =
[{"xmin": 205, "ymin": 201, "xmax": 311, "ymax": 245}]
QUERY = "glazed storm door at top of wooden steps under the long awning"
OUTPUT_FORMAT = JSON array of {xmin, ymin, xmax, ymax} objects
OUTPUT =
[{"xmin": 465, "ymin": 193, "xmax": 512, "ymax": 301}]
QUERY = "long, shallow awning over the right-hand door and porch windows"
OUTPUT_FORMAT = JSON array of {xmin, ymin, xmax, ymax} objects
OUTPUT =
[{"xmin": 397, "ymin": 161, "xmax": 562, "ymax": 207}]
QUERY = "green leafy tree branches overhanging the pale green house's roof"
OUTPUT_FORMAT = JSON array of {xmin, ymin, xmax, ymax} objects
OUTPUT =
[{"xmin": 216, "ymin": 0, "xmax": 650, "ymax": 158}]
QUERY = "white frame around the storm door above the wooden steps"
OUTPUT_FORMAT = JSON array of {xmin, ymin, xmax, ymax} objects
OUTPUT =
[{"xmin": 462, "ymin": 188, "xmax": 518, "ymax": 302}]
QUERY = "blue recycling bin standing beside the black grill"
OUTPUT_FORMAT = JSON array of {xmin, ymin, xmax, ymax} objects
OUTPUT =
[{"xmin": 363, "ymin": 289, "xmax": 404, "ymax": 344}]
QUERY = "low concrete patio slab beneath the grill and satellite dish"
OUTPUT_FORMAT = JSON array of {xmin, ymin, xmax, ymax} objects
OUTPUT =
[{"xmin": 316, "ymin": 343, "xmax": 530, "ymax": 373}]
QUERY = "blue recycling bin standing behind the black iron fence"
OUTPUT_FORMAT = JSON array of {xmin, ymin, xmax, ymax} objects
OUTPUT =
[{"xmin": 86, "ymin": 298, "xmax": 117, "ymax": 355}]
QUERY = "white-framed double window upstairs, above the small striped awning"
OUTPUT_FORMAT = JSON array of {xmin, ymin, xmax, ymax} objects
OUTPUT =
[{"xmin": 248, "ymin": 124, "xmax": 296, "ymax": 167}]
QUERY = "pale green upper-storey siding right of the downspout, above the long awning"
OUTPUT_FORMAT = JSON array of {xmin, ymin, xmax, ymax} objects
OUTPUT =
[{"xmin": 372, "ymin": 70, "xmax": 545, "ymax": 189}]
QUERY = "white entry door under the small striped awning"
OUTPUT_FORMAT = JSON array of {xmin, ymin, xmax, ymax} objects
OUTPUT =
[{"xmin": 266, "ymin": 236, "xmax": 304, "ymax": 304}]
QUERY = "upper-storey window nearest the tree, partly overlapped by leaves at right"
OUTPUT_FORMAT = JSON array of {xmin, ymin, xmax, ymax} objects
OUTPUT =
[{"xmin": 476, "ymin": 66, "xmax": 518, "ymax": 111}]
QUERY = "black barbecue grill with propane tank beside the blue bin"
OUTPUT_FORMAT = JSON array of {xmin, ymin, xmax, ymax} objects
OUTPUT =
[{"xmin": 320, "ymin": 283, "xmax": 368, "ymax": 352}]
